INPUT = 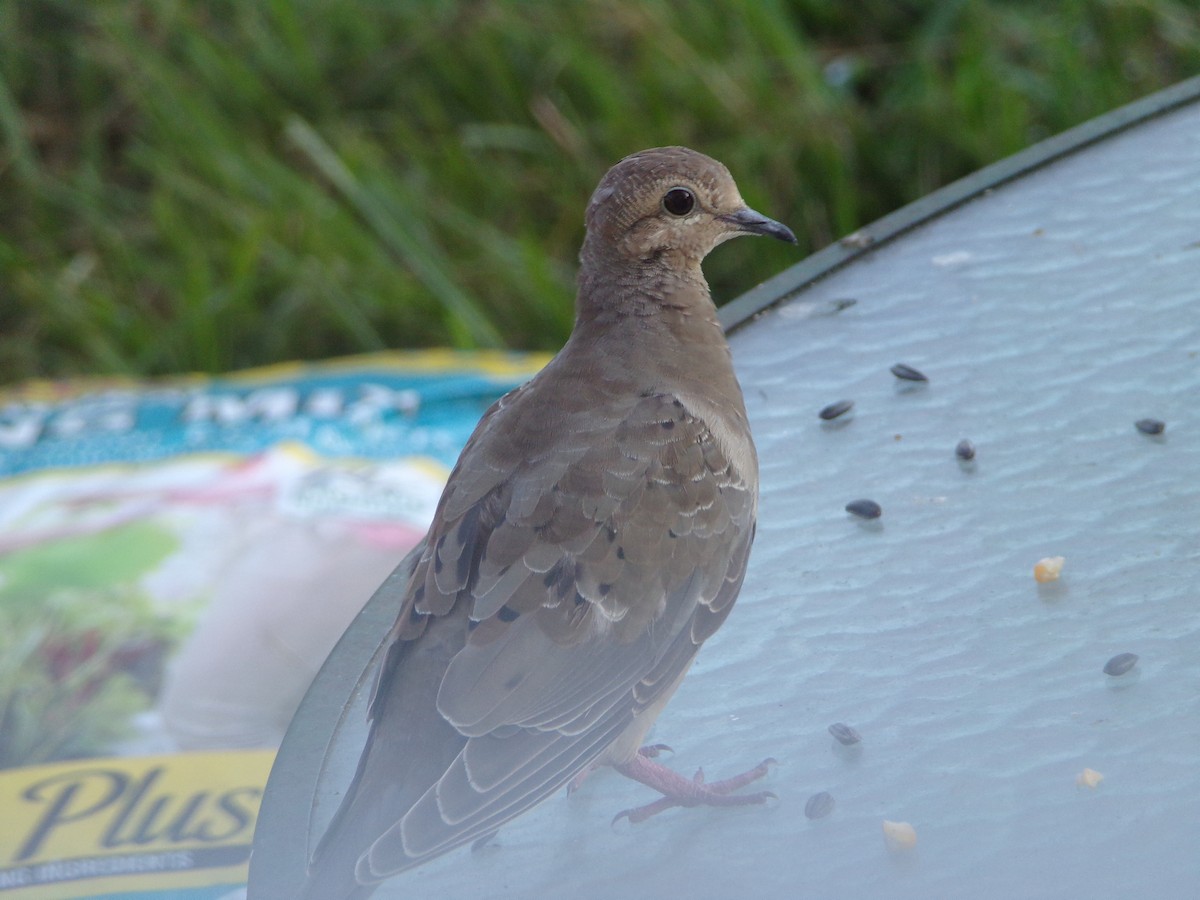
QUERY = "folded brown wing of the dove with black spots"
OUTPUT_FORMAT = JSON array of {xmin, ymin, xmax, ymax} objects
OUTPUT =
[{"xmin": 302, "ymin": 364, "xmax": 756, "ymax": 882}]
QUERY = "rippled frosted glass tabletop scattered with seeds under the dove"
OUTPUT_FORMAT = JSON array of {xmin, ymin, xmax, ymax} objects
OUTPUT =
[{"xmin": 252, "ymin": 79, "xmax": 1200, "ymax": 900}]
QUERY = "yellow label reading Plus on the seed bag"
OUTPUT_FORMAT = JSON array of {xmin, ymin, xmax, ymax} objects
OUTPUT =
[{"xmin": 0, "ymin": 750, "xmax": 275, "ymax": 900}]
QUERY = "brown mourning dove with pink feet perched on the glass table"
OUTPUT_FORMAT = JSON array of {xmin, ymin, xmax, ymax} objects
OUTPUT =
[{"xmin": 294, "ymin": 148, "xmax": 796, "ymax": 900}]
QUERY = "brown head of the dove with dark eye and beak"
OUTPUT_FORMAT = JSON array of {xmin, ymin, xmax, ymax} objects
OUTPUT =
[{"xmin": 582, "ymin": 146, "xmax": 796, "ymax": 266}]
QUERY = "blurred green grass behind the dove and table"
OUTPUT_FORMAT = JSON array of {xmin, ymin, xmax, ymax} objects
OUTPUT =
[{"xmin": 0, "ymin": 0, "xmax": 1200, "ymax": 383}]
